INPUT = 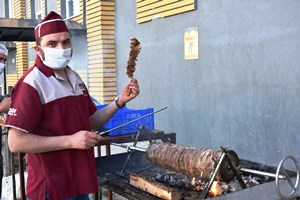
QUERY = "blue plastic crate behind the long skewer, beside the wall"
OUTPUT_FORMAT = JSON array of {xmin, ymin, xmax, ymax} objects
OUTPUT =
[{"xmin": 97, "ymin": 105, "xmax": 154, "ymax": 136}]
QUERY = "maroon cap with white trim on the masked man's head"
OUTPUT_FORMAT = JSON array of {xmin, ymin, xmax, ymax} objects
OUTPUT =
[{"xmin": 34, "ymin": 11, "xmax": 69, "ymax": 39}]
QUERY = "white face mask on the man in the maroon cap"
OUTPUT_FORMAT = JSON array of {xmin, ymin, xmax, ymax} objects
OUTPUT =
[{"xmin": 41, "ymin": 47, "xmax": 72, "ymax": 70}]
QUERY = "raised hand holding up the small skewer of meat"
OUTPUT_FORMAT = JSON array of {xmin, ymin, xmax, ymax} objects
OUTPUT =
[{"xmin": 119, "ymin": 78, "xmax": 140, "ymax": 105}]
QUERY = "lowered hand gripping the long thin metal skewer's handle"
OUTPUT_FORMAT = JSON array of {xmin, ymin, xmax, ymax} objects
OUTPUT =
[{"xmin": 71, "ymin": 131, "xmax": 102, "ymax": 149}]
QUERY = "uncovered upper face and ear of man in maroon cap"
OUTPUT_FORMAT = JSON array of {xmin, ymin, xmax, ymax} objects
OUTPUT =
[{"xmin": 34, "ymin": 32, "xmax": 72, "ymax": 59}]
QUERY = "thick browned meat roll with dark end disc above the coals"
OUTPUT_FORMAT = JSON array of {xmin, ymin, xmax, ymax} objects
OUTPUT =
[{"xmin": 146, "ymin": 143, "xmax": 239, "ymax": 182}]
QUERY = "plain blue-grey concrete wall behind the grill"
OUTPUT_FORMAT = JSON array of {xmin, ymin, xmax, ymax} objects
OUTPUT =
[{"xmin": 116, "ymin": 0, "xmax": 300, "ymax": 164}]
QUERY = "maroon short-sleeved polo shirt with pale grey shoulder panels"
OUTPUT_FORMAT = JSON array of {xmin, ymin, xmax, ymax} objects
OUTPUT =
[{"xmin": 5, "ymin": 57, "xmax": 98, "ymax": 200}]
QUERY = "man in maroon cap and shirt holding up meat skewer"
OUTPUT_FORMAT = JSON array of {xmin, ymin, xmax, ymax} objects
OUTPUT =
[{"xmin": 5, "ymin": 12, "xmax": 139, "ymax": 200}]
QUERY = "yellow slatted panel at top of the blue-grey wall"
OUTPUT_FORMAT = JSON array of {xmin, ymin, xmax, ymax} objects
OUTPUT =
[{"xmin": 136, "ymin": 0, "xmax": 196, "ymax": 23}]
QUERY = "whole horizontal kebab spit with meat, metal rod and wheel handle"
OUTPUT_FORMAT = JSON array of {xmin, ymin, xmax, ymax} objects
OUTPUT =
[{"xmin": 106, "ymin": 141, "xmax": 299, "ymax": 199}]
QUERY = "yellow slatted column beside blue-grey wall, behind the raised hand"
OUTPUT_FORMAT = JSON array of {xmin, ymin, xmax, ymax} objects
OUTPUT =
[{"xmin": 86, "ymin": 0, "xmax": 116, "ymax": 104}]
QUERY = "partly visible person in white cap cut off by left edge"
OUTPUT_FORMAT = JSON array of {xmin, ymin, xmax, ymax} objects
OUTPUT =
[{"xmin": 0, "ymin": 44, "xmax": 10, "ymax": 199}]
